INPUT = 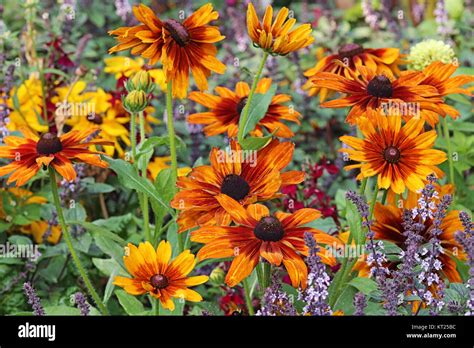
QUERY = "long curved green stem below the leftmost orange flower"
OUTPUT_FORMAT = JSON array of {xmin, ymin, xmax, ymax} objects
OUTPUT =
[{"xmin": 48, "ymin": 166, "xmax": 109, "ymax": 315}]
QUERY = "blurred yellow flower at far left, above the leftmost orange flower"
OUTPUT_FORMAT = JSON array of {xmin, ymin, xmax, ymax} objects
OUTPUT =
[{"xmin": 7, "ymin": 74, "xmax": 48, "ymax": 132}]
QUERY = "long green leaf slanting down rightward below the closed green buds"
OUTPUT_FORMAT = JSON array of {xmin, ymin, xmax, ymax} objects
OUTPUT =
[{"xmin": 105, "ymin": 157, "xmax": 170, "ymax": 212}]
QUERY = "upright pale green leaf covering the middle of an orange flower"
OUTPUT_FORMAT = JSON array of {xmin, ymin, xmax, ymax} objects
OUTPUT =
[{"xmin": 239, "ymin": 85, "xmax": 277, "ymax": 141}]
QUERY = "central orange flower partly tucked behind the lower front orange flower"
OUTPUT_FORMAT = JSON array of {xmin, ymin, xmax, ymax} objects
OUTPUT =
[{"xmin": 171, "ymin": 139, "xmax": 305, "ymax": 232}]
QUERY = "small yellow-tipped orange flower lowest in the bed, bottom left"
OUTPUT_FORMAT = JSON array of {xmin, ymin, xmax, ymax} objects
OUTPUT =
[{"xmin": 114, "ymin": 240, "xmax": 209, "ymax": 311}]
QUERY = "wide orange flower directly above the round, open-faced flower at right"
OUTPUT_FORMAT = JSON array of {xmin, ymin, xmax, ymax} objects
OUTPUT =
[{"xmin": 311, "ymin": 62, "xmax": 444, "ymax": 125}]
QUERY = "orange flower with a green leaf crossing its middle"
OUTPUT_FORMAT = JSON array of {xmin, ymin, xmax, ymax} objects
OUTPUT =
[{"xmin": 188, "ymin": 78, "xmax": 301, "ymax": 138}]
